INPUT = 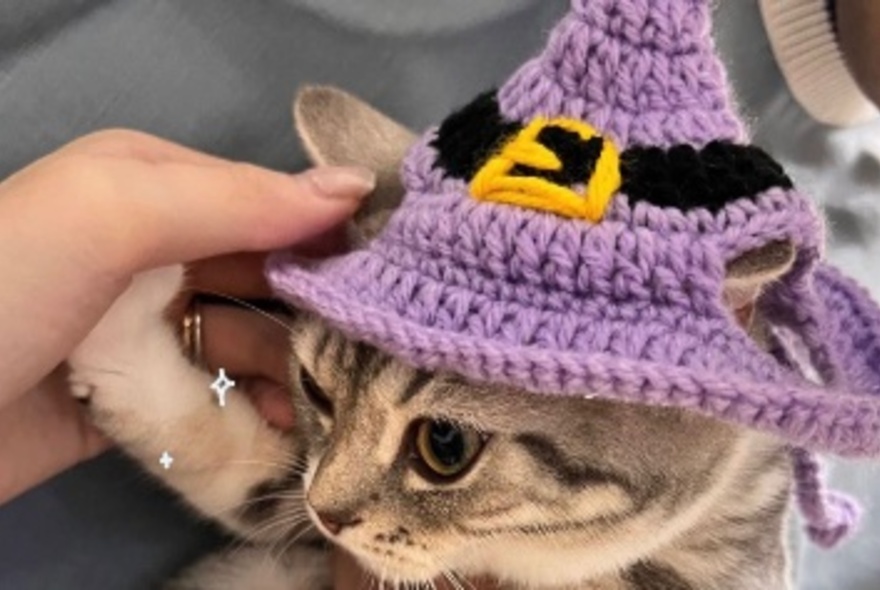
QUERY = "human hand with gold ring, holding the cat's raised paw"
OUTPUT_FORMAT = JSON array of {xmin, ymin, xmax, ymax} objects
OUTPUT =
[{"xmin": 0, "ymin": 131, "xmax": 374, "ymax": 502}]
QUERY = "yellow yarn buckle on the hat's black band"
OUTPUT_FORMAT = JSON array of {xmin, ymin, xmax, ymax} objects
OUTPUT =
[{"xmin": 470, "ymin": 117, "xmax": 621, "ymax": 223}]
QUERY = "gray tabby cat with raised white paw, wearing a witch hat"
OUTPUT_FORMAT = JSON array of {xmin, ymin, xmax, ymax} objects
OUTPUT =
[{"xmin": 70, "ymin": 88, "xmax": 792, "ymax": 590}]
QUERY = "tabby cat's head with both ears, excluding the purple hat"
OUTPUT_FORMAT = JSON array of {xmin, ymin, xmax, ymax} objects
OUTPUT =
[{"xmin": 292, "ymin": 88, "xmax": 794, "ymax": 586}]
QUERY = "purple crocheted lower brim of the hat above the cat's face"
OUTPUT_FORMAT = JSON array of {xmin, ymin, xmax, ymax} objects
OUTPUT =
[{"xmin": 267, "ymin": 251, "xmax": 880, "ymax": 456}]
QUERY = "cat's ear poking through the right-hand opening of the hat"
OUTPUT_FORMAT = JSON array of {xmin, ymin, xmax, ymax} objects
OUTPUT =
[{"xmin": 724, "ymin": 240, "xmax": 796, "ymax": 329}]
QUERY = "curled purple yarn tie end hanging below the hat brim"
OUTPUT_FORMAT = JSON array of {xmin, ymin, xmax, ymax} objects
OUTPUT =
[{"xmin": 792, "ymin": 449, "xmax": 861, "ymax": 549}]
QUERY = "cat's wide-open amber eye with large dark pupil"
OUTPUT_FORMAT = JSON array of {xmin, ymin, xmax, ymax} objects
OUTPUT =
[{"xmin": 413, "ymin": 420, "xmax": 486, "ymax": 483}]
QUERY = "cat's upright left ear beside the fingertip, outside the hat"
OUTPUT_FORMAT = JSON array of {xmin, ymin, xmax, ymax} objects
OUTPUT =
[{"xmin": 293, "ymin": 86, "xmax": 417, "ymax": 234}]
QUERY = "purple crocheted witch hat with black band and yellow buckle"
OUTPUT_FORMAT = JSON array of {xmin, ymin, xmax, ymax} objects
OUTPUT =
[{"xmin": 269, "ymin": 0, "xmax": 880, "ymax": 545}]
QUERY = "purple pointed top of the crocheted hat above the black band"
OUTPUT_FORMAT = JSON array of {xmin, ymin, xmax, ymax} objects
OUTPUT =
[{"xmin": 499, "ymin": 0, "xmax": 745, "ymax": 147}]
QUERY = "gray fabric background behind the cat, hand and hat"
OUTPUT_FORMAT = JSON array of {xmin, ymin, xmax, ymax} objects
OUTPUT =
[{"xmin": 0, "ymin": 0, "xmax": 880, "ymax": 590}]
